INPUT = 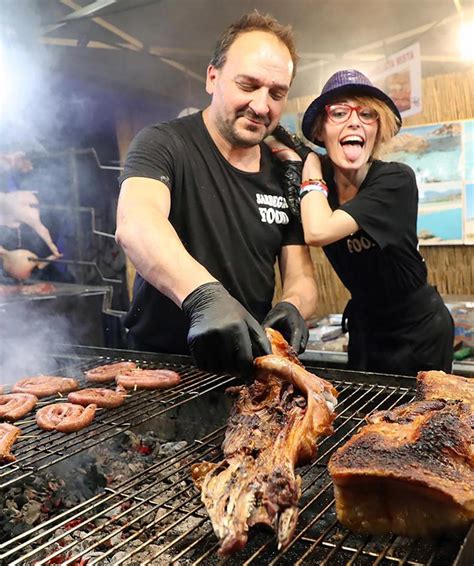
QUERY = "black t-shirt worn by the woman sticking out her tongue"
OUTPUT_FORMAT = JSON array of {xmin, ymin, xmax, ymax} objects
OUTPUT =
[{"xmin": 323, "ymin": 160, "xmax": 427, "ymax": 308}]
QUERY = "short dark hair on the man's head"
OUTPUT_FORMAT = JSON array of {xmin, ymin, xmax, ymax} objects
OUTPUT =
[{"xmin": 209, "ymin": 10, "xmax": 298, "ymax": 79}]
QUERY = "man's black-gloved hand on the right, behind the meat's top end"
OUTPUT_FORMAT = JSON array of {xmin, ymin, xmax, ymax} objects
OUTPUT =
[{"xmin": 262, "ymin": 301, "xmax": 309, "ymax": 354}]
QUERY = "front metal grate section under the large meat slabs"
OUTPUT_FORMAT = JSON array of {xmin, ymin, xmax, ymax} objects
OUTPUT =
[{"xmin": 0, "ymin": 364, "xmax": 474, "ymax": 566}]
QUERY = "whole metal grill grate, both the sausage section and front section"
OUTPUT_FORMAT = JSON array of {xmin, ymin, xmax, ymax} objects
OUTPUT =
[{"xmin": 0, "ymin": 349, "xmax": 474, "ymax": 566}]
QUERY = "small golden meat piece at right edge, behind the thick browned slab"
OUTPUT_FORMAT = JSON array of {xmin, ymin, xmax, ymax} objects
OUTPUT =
[{"xmin": 416, "ymin": 371, "xmax": 474, "ymax": 413}]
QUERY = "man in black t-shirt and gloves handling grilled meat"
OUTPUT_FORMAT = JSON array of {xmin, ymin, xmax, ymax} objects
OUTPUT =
[{"xmin": 116, "ymin": 12, "xmax": 316, "ymax": 375}]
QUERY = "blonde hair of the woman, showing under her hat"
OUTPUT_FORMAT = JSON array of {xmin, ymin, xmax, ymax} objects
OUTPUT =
[{"xmin": 311, "ymin": 95, "xmax": 400, "ymax": 158}]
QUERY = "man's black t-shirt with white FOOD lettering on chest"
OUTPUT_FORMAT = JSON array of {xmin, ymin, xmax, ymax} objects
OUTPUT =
[{"xmin": 120, "ymin": 113, "xmax": 304, "ymax": 353}]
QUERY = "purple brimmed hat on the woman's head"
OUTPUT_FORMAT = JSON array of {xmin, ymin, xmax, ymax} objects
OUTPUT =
[{"xmin": 301, "ymin": 69, "xmax": 402, "ymax": 147}]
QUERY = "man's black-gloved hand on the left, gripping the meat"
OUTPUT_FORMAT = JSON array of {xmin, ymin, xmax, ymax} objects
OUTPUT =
[{"xmin": 182, "ymin": 282, "xmax": 271, "ymax": 377}]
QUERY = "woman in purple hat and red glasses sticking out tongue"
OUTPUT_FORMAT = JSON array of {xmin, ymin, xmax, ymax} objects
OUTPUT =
[{"xmin": 270, "ymin": 70, "xmax": 454, "ymax": 375}]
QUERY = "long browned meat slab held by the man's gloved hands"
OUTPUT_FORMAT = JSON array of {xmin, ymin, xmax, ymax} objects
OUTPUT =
[{"xmin": 192, "ymin": 330, "xmax": 337, "ymax": 555}]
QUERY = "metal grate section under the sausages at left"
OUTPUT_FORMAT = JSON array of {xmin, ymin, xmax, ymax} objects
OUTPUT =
[{"xmin": 0, "ymin": 348, "xmax": 235, "ymax": 489}]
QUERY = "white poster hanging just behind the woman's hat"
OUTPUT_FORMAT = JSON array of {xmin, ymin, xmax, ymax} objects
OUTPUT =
[{"xmin": 369, "ymin": 43, "xmax": 422, "ymax": 118}]
